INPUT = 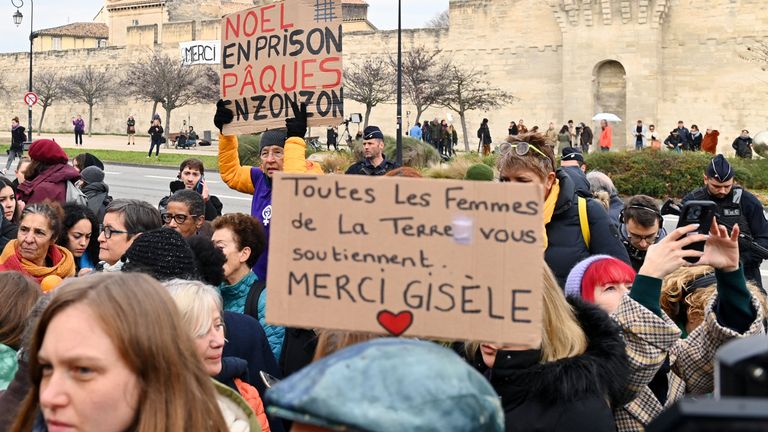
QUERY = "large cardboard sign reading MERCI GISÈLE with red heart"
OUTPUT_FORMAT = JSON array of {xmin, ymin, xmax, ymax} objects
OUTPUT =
[{"xmin": 266, "ymin": 173, "xmax": 544, "ymax": 347}]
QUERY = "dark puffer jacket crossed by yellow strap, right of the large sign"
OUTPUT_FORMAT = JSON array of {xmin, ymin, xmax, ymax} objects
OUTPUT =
[{"xmin": 544, "ymin": 170, "xmax": 629, "ymax": 287}]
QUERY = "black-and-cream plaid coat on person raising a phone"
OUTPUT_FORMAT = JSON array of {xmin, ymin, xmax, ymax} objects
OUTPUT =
[{"xmin": 613, "ymin": 295, "xmax": 765, "ymax": 432}]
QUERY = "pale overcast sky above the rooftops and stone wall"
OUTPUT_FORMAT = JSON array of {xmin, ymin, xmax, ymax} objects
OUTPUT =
[{"xmin": 0, "ymin": 0, "xmax": 448, "ymax": 52}]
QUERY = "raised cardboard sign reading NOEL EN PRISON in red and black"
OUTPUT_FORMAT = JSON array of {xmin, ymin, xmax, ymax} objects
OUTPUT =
[{"xmin": 221, "ymin": 0, "xmax": 344, "ymax": 135}]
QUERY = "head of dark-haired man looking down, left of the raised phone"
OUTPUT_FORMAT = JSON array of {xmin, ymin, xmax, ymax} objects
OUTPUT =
[{"xmin": 619, "ymin": 195, "xmax": 667, "ymax": 271}]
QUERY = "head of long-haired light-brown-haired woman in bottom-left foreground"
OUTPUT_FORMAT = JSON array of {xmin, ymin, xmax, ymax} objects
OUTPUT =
[{"xmin": 11, "ymin": 274, "xmax": 229, "ymax": 432}]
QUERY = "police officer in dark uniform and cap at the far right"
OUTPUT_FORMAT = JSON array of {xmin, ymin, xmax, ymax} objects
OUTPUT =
[{"xmin": 683, "ymin": 155, "xmax": 768, "ymax": 288}]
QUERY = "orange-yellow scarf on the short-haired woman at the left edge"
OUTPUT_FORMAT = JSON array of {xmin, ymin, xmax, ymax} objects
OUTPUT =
[{"xmin": 0, "ymin": 240, "xmax": 75, "ymax": 290}]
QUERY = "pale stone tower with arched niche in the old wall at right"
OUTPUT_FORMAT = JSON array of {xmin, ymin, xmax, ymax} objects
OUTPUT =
[{"xmin": 550, "ymin": 0, "xmax": 670, "ymax": 146}]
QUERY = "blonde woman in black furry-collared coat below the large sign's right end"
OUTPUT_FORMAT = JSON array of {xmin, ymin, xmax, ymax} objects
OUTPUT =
[{"xmin": 467, "ymin": 268, "xmax": 629, "ymax": 432}]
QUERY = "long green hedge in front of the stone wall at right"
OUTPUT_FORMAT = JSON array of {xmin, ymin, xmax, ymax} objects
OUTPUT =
[{"xmin": 585, "ymin": 149, "xmax": 768, "ymax": 198}]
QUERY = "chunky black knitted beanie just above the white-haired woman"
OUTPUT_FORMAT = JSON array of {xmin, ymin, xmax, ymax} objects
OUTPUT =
[{"xmin": 123, "ymin": 228, "xmax": 197, "ymax": 281}]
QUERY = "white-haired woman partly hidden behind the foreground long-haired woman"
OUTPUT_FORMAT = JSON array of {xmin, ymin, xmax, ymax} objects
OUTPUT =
[{"xmin": 164, "ymin": 279, "xmax": 270, "ymax": 432}]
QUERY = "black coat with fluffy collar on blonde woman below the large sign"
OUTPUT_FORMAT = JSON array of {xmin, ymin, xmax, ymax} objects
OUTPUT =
[{"xmin": 489, "ymin": 298, "xmax": 630, "ymax": 432}]
